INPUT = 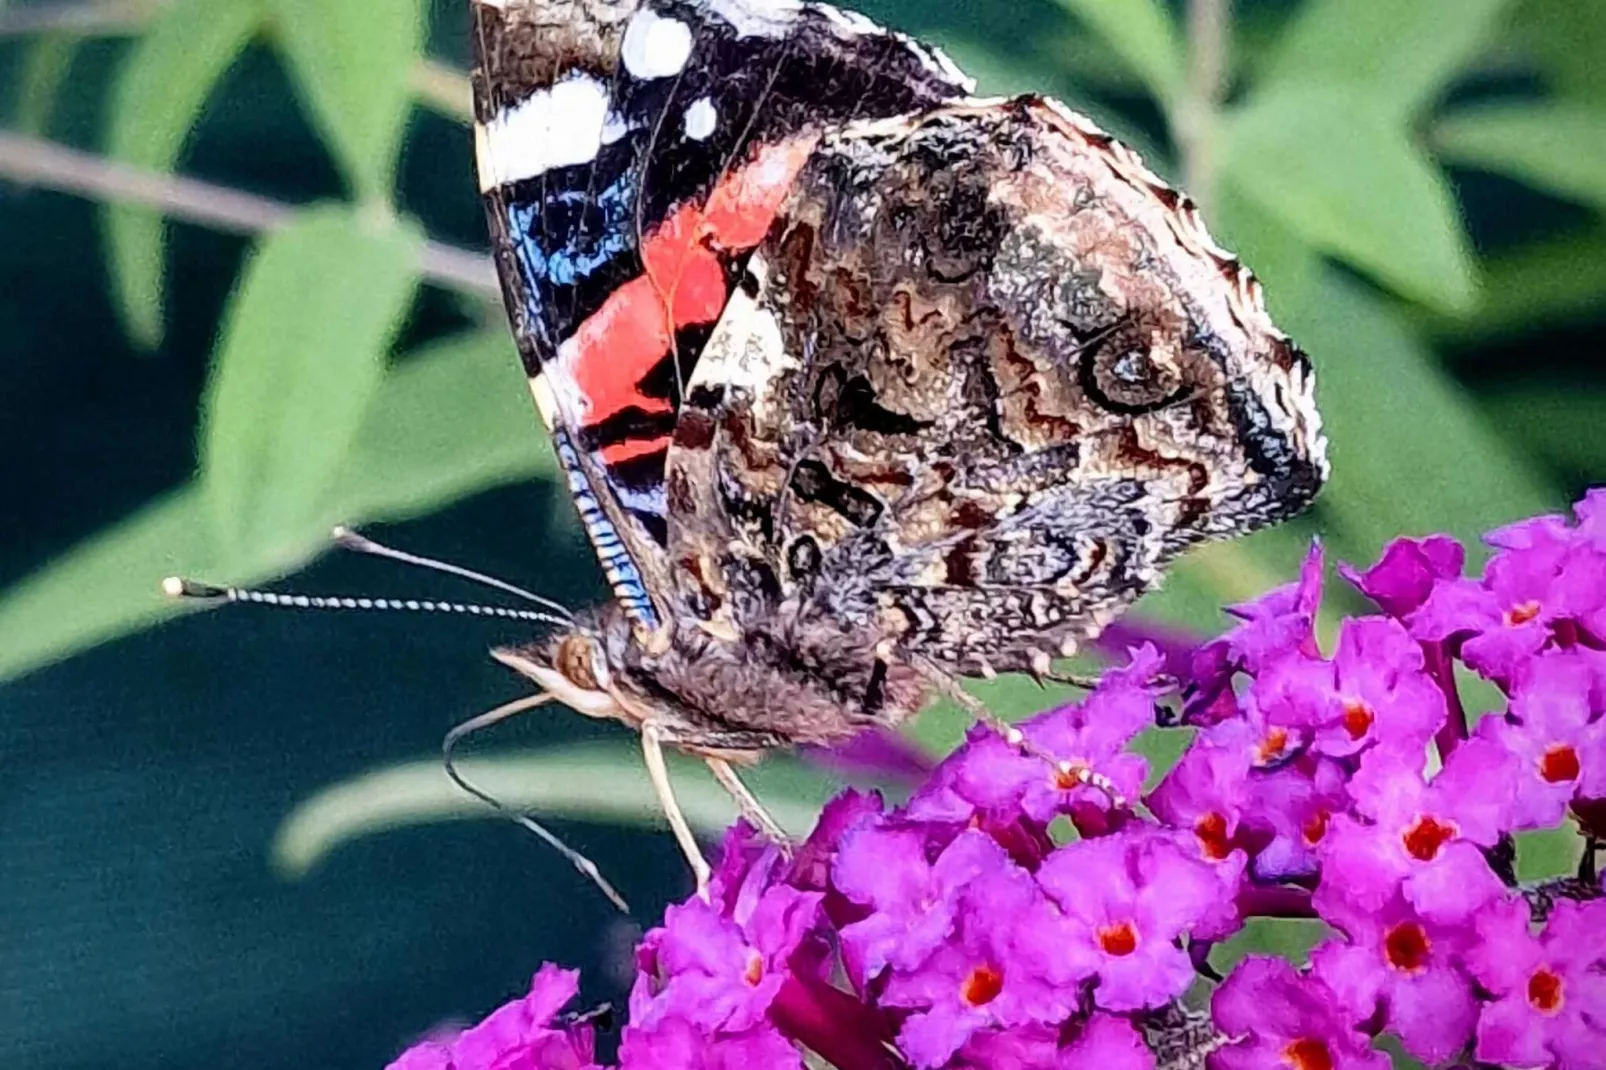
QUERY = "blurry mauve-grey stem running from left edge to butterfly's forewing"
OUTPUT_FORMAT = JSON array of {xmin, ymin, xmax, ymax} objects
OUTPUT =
[{"xmin": 0, "ymin": 132, "xmax": 498, "ymax": 294}]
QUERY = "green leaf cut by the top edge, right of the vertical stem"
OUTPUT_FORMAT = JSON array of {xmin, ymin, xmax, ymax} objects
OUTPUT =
[{"xmin": 1257, "ymin": 0, "xmax": 1506, "ymax": 117}]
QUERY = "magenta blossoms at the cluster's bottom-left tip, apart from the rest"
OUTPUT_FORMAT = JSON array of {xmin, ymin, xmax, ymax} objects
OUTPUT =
[{"xmin": 390, "ymin": 964, "xmax": 596, "ymax": 1070}]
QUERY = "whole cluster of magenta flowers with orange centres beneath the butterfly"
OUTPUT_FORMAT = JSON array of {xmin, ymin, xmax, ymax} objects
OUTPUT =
[{"xmin": 393, "ymin": 492, "xmax": 1606, "ymax": 1070}]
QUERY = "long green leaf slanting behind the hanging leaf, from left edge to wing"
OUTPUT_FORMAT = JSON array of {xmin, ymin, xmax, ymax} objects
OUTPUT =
[{"xmin": 0, "ymin": 324, "xmax": 551, "ymax": 680}]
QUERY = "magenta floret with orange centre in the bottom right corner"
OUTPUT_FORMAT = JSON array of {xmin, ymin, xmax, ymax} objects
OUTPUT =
[{"xmin": 1466, "ymin": 898, "xmax": 1606, "ymax": 1070}]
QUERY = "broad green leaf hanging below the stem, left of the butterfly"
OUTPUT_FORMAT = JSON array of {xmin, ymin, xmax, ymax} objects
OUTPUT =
[{"xmin": 201, "ymin": 207, "xmax": 421, "ymax": 561}]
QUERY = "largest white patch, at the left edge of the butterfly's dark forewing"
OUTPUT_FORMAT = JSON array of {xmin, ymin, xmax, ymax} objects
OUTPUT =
[{"xmin": 475, "ymin": 74, "xmax": 609, "ymax": 190}]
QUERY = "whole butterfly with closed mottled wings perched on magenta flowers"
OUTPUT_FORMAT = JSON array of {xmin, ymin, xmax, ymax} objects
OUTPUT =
[{"xmin": 471, "ymin": 0, "xmax": 1328, "ymax": 882}]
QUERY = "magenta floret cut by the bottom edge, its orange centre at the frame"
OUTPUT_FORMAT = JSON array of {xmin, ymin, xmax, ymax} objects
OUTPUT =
[{"xmin": 1209, "ymin": 956, "xmax": 1389, "ymax": 1070}]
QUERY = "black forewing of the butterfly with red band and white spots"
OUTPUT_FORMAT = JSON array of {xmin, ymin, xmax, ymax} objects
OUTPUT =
[{"xmin": 472, "ymin": 0, "xmax": 970, "ymax": 631}]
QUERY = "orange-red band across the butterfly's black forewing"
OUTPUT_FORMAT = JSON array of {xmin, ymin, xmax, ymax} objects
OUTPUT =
[{"xmin": 560, "ymin": 135, "xmax": 819, "ymax": 430}]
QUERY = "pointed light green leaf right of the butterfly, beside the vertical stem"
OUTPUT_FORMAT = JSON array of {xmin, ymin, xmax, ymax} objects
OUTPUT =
[{"xmin": 1224, "ymin": 90, "xmax": 1476, "ymax": 312}]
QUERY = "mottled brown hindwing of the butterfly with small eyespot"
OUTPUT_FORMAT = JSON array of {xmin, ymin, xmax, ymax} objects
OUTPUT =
[{"xmin": 668, "ymin": 98, "xmax": 1327, "ymax": 672}]
